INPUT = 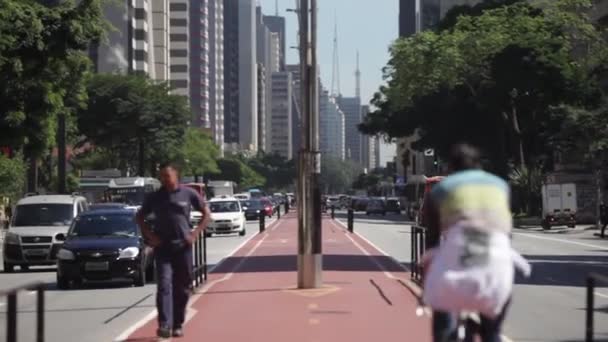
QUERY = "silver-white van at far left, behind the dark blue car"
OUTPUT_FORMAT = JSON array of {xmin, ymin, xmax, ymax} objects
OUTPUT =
[{"xmin": 3, "ymin": 195, "xmax": 88, "ymax": 272}]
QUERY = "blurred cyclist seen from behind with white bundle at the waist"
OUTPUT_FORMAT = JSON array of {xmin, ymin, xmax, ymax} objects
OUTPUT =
[{"xmin": 424, "ymin": 145, "xmax": 530, "ymax": 342}]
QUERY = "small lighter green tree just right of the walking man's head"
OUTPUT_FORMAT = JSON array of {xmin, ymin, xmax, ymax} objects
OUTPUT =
[{"xmin": 182, "ymin": 127, "xmax": 220, "ymax": 181}]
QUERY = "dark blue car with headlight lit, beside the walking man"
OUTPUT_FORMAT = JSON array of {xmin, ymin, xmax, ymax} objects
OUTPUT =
[{"xmin": 57, "ymin": 209, "xmax": 153, "ymax": 289}]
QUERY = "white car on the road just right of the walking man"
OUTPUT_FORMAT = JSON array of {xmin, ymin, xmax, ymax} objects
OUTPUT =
[{"xmin": 205, "ymin": 197, "xmax": 247, "ymax": 236}]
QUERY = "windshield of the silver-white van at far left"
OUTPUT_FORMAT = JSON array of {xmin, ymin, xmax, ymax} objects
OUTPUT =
[{"xmin": 13, "ymin": 203, "xmax": 74, "ymax": 227}]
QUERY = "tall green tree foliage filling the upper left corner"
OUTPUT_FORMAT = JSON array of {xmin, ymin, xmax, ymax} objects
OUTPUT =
[{"xmin": 0, "ymin": 0, "xmax": 107, "ymax": 187}]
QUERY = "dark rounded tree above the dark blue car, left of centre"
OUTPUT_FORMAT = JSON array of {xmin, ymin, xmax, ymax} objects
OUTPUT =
[{"xmin": 78, "ymin": 74, "xmax": 191, "ymax": 175}]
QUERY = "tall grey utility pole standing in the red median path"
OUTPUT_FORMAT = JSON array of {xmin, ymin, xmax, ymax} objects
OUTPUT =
[{"xmin": 297, "ymin": 0, "xmax": 323, "ymax": 289}]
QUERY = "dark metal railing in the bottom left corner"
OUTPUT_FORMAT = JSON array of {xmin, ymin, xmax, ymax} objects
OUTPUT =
[{"xmin": 0, "ymin": 283, "xmax": 46, "ymax": 342}]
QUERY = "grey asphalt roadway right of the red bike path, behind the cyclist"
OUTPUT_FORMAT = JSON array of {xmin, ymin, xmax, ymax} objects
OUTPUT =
[{"xmin": 337, "ymin": 212, "xmax": 608, "ymax": 342}]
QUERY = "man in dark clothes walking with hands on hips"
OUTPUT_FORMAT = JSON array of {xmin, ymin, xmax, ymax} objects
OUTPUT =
[{"xmin": 137, "ymin": 164, "xmax": 210, "ymax": 338}]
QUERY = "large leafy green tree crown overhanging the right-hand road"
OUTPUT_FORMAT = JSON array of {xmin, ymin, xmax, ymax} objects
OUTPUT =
[{"xmin": 360, "ymin": 0, "xmax": 607, "ymax": 176}]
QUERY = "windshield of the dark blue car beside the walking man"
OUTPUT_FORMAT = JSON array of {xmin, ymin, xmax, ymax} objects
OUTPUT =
[{"xmin": 68, "ymin": 214, "xmax": 138, "ymax": 237}]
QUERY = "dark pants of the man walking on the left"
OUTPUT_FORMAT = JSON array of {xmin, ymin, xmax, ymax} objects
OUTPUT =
[{"xmin": 154, "ymin": 247, "xmax": 192, "ymax": 328}]
